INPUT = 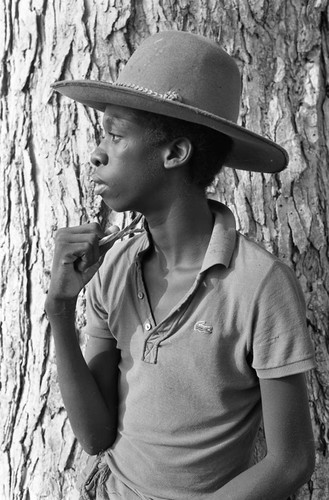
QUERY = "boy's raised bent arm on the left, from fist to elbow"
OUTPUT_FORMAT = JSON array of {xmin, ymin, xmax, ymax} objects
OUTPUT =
[{"xmin": 45, "ymin": 224, "xmax": 119, "ymax": 455}]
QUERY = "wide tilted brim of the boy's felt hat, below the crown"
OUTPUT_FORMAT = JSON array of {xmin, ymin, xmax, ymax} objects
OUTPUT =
[{"xmin": 52, "ymin": 80, "xmax": 289, "ymax": 174}]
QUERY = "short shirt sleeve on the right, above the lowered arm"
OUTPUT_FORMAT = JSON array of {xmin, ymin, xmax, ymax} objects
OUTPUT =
[{"xmin": 250, "ymin": 261, "xmax": 315, "ymax": 378}]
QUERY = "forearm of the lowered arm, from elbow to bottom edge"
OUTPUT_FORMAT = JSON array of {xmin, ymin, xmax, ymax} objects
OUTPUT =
[{"xmin": 214, "ymin": 455, "xmax": 311, "ymax": 500}]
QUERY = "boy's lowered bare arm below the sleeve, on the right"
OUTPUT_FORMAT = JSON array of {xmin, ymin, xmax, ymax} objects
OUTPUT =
[{"xmin": 217, "ymin": 374, "xmax": 314, "ymax": 500}]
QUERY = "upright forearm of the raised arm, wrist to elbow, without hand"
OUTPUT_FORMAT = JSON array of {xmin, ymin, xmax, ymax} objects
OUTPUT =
[{"xmin": 46, "ymin": 301, "xmax": 117, "ymax": 454}]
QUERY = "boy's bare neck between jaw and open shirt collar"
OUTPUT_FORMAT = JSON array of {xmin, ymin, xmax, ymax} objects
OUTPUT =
[{"xmin": 146, "ymin": 192, "xmax": 213, "ymax": 269}]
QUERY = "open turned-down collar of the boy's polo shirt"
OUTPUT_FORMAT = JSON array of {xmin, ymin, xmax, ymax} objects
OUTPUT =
[{"xmin": 138, "ymin": 200, "xmax": 236, "ymax": 273}]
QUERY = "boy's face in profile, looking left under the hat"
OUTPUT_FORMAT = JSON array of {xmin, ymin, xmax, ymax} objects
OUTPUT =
[{"xmin": 91, "ymin": 105, "xmax": 165, "ymax": 213}]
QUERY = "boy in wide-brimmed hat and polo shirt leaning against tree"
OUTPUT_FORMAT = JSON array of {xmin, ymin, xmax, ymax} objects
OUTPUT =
[{"xmin": 46, "ymin": 31, "xmax": 314, "ymax": 500}]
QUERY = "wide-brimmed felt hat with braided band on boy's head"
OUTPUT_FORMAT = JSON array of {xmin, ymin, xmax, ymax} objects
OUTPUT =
[{"xmin": 52, "ymin": 31, "xmax": 288, "ymax": 173}]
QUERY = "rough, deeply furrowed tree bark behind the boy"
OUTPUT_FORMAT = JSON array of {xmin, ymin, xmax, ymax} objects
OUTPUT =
[{"xmin": 0, "ymin": 0, "xmax": 329, "ymax": 500}]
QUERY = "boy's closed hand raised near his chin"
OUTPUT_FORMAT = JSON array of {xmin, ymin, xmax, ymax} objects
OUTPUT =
[{"xmin": 47, "ymin": 223, "xmax": 118, "ymax": 306}]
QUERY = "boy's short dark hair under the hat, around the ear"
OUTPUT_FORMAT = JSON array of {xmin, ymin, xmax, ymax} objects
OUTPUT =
[{"xmin": 140, "ymin": 111, "xmax": 232, "ymax": 190}]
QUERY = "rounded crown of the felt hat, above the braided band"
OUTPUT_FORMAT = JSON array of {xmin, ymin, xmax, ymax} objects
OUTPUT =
[{"xmin": 117, "ymin": 31, "xmax": 241, "ymax": 122}]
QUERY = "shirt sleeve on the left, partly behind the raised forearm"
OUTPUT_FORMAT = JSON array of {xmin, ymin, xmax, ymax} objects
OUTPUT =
[{"xmin": 84, "ymin": 272, "xmax": 113, "ymax": 339}]
